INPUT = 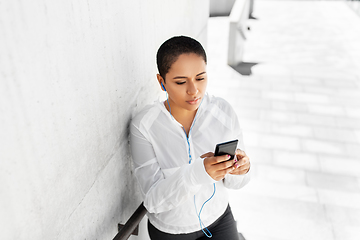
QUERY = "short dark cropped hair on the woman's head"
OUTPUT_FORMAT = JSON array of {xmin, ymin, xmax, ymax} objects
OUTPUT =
[{"xmin": 156, "ymin": 36, "xmax": 207, "ymax": 80}]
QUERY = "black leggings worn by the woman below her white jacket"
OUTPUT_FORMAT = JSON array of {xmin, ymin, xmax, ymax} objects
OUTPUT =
[{"xmin": 148, "ymin": 206, "xmax": 239, "ymax": 240}]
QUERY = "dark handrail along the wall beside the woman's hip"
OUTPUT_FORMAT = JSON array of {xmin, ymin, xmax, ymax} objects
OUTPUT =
[{"xmin": 113, "ymin": 202, "xmax": 147, "ymax": 240}]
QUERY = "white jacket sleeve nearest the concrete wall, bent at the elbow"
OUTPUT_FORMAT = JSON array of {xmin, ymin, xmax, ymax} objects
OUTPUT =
[{"xmin": 130, "ymin": 124, "xmax": 215, "ymax": 213}]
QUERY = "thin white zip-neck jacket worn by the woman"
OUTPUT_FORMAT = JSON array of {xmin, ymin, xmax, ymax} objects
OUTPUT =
[{"xmin": 130, "ymin": 94, "xmax": 250, "ymax": 234}]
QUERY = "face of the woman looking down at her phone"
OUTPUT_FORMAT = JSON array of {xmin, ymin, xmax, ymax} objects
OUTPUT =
[{"xmin": 158, "ymin": 53, "xmax": 207, "ymax": 114}]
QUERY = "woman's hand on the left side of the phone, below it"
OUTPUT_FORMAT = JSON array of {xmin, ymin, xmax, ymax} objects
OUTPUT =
[{"xmin": 201, "ymin": 152, "xmax": 235, "ymax": 181}]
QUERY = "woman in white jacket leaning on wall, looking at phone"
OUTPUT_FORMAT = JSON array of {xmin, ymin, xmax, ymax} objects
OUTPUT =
[{"xmin": 130, "ymin": 36, "xmax": 250, "ymax": 240}]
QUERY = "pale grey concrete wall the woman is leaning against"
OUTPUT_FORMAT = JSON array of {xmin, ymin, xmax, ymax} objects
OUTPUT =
[{"xmin": 0, "ymin": 0, "xmax": 209, "ymax": 240}]
